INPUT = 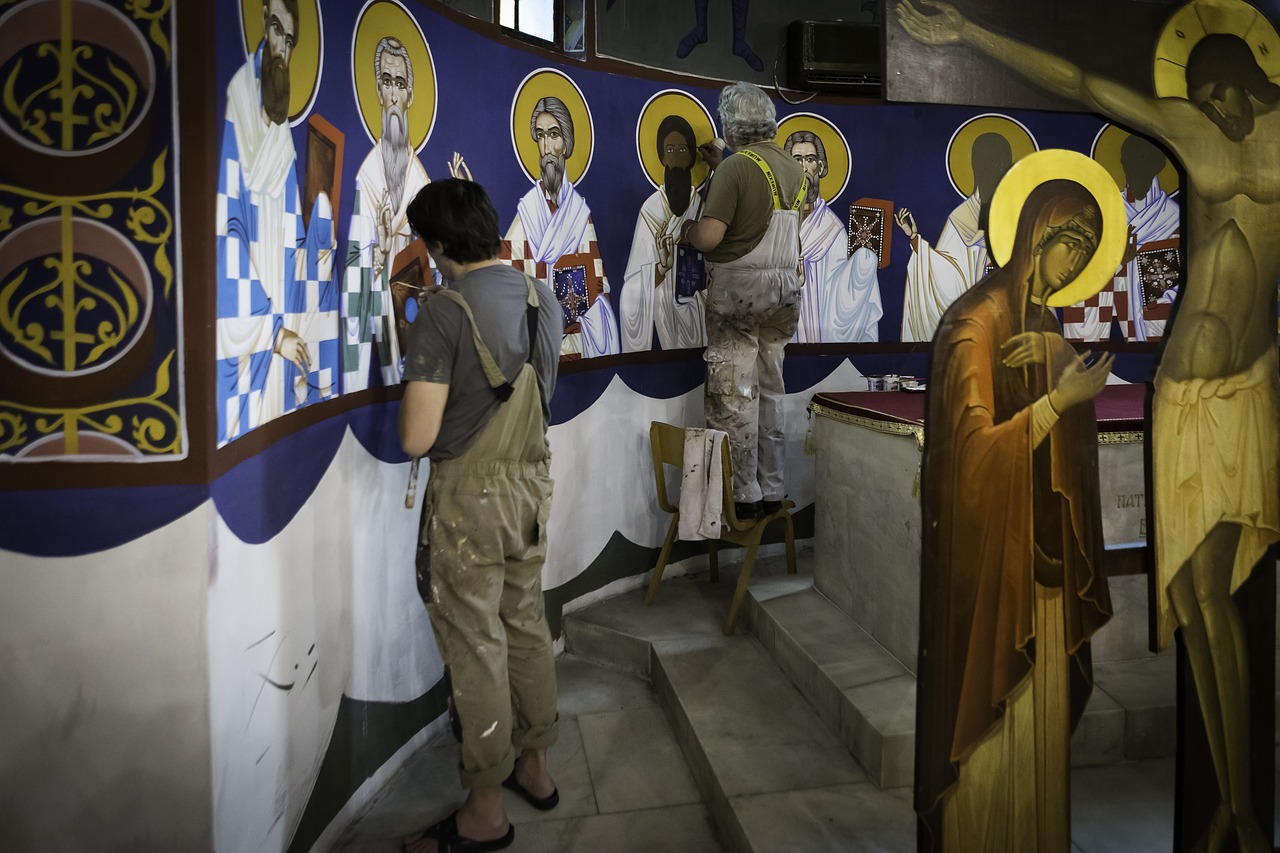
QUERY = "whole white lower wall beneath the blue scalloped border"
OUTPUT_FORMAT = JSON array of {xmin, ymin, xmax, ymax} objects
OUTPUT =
[{"xmin": 0, "ymin": 362, "xmax": 860, "ymax": 853}]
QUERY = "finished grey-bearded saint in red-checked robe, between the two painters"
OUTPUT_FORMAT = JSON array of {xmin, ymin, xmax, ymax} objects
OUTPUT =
[{"xmin": 499, "ymin": 68, "xmax": 620, "ymax": 359}]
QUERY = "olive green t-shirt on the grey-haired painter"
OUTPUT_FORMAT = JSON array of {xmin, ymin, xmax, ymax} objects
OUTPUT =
[{"xmin": 703, "ymin": 140, "xmax": 804, "ymax": 264}]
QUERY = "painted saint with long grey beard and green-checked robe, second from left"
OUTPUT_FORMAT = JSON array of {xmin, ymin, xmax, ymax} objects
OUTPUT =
[{"xmin": 342, "ymin": 0, "xmax": 436, "ymax": 392}]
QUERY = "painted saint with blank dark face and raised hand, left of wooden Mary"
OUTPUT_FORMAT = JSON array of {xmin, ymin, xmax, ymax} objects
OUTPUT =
[{"xmin": 893, "ymin": 114, "xmax": 1038, "ymax": 341}]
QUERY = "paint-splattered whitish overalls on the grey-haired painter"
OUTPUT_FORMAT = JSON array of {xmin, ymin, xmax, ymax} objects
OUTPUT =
[{"xmin": 705, "ymin": 149, "xmax": 809, "ymax": 503}]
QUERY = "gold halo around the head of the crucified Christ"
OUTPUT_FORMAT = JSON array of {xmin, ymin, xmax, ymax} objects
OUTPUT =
[{"xmin": 1152, "ymin": 0, "xmax": 1280, "ymax": 100}]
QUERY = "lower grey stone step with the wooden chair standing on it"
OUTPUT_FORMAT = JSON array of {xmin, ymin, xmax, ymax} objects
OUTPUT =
[{"xmin": 564, "ymin": 558, "xmax": 915, "ymax": 853}]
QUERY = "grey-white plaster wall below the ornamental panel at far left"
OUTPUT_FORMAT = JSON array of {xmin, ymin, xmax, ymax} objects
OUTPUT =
[{"xmin": 0, "ymin": 503, "xmax": 212, "ymax": 850}]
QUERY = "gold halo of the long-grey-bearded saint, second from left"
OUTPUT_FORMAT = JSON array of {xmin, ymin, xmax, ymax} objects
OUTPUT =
[{"xmin": 351, "ymin": 0, "xmax": 436, "ymax": 151}]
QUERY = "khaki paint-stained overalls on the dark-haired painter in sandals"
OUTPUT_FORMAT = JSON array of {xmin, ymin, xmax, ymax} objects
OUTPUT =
[{"xmin": 421, "ymin": 280, "xmax": 557, "ymax": 788}]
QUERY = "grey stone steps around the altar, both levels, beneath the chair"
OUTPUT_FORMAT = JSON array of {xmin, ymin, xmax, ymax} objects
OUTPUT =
[{"xmin": 564, "ymin": 549, "xmax": 1175, "ymax": 852}]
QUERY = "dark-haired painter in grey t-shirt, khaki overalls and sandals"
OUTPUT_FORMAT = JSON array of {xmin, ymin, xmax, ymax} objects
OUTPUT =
[{"xmin": 399, "ymin": 179, "xmax": 562, "ymax": 853}]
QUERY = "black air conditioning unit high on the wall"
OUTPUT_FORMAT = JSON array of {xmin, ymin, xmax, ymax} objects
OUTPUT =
[{"xmin": 787, "ymin": 20, "xmax": 884, "ymax": 97}]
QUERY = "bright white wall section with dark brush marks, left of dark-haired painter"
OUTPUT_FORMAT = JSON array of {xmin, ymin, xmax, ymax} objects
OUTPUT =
[{"xmin": 209, "ymin": 433, "xmax": 432, "ymax": 853}]
